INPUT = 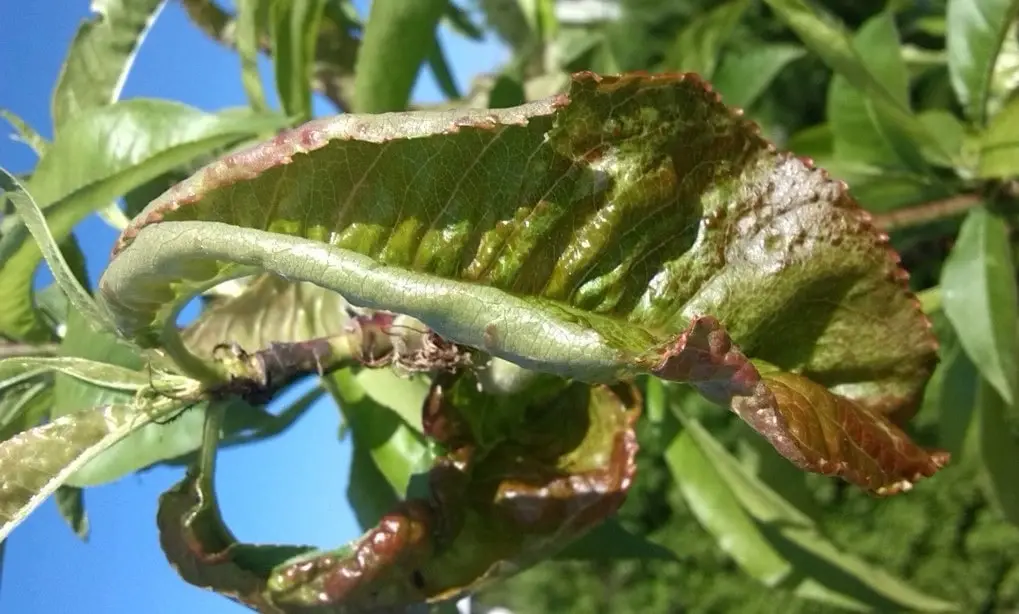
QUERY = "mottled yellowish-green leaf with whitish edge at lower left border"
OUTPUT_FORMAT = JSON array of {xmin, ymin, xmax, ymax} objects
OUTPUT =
[{"xmin": 0, "ymin": 404, "xmax": 179, "ymax": 540}]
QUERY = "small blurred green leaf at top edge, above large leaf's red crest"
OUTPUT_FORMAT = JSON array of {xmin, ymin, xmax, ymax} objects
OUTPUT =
[{"xmin": 662, "ymin": 0, "xmax": 750, "ymax": 79}]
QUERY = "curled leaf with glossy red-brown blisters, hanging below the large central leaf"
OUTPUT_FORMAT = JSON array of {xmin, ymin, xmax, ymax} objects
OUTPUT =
[{"xmin": 268, "ymin": 376, "xmax": 642, "ymax": 614}]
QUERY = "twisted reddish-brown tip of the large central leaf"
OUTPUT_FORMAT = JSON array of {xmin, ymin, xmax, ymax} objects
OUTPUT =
[{"xmin": 653, "ymin": 316, "xmax": 950, "ymax": 496}]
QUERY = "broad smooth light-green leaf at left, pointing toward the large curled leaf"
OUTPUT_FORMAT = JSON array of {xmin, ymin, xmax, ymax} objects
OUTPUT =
[{"xmin": 0, "ymin": 99, "xmax": 282, "ymax": 341}]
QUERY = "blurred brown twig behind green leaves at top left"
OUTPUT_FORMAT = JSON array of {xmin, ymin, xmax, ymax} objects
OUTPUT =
[{"xmin": 180, "ymin": 0, "xmax": 358, "ymax": 112}]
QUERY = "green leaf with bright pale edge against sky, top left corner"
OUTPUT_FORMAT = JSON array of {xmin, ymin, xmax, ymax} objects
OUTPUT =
[{"xmin": 50, "ymin": 0, "xmax": 165, "ymax": 131}]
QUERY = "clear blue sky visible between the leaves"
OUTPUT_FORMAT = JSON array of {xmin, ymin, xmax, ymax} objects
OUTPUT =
[{"xmin": 0, "ymin": 0, "xmax": 506, "ymax": 614}]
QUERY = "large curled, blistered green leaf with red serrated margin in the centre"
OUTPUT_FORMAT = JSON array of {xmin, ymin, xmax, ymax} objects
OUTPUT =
[{"xmin": 100, "ymin": 73, "xmax": 934, "ymax": 454}]
